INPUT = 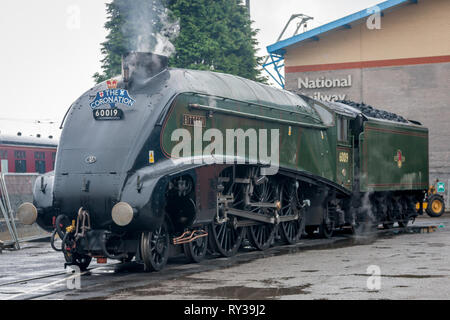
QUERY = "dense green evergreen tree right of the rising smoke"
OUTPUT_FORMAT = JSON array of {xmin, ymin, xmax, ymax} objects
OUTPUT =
[{"xmin": 165, "ymin": 0, "xmax": 263, "ymax": 81}]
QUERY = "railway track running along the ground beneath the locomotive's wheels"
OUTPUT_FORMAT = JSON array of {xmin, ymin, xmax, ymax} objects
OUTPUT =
[{"xmin": 0, "ymin": 224, "xmax": 442, "ymax": 300}]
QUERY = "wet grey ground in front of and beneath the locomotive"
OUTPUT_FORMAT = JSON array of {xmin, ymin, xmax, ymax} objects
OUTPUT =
[{"xmin": 0, "ymin": 214, "xmax": 450, "ymax": 300}]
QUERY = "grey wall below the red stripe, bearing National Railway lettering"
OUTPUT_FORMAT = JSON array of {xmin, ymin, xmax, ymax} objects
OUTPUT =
[{"xmin": 286, "ymin": 63, "xmax": 450, "ymax": 187}]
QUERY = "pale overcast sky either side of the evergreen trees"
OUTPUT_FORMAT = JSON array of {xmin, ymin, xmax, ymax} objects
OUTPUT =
[{"xmin": 0, "ymin": 0, "xmax": 381, "ymax": 136}]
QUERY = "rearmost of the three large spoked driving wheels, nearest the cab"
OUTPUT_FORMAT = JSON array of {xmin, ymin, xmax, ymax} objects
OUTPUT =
[{"xmin": 279, "ymin": 180, "xmax": 305, "ymax": 244}]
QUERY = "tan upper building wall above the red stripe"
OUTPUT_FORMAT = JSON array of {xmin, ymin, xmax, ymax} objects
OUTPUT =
[{"xmin": 285, "ymin": 0, "xmax": 450, "ymax": 72}]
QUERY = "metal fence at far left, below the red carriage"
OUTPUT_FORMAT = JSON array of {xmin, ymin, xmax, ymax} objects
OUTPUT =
[{"xmin": 0, "ymin": 173, "xmax": 49, "ymax": 249}]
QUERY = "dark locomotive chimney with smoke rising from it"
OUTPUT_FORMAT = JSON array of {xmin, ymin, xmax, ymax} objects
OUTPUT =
[{"xmin": 122, "ymin": 51, "xmax": 169, "ymax": 87}]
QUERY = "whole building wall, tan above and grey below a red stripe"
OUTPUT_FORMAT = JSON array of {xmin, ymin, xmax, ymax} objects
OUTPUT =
[{"xmin": 285, "ymin": 0, "xmax": 450, "ymax": 187}]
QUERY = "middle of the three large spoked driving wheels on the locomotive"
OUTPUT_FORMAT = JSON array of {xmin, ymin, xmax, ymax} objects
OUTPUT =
[{"xmin": 248, "ymin": 169, "xmax": 277, "ymax": 250}]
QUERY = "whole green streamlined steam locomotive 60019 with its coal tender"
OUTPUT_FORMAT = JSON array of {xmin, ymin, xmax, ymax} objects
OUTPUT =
[{"xmin": 17, "ymin": 52, "xmax": 428, "ymax": 270}]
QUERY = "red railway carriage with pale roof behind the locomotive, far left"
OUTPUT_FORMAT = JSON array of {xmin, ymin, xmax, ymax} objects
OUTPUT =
[{"xmin": 0, "ymin": 135, "xmax": 58, "ymax": 173}]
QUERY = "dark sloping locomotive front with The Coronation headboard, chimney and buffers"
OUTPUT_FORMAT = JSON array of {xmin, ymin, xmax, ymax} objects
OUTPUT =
[{"xmin": 19, "ymin": 53, "xmax": 192, "ymax": 266}]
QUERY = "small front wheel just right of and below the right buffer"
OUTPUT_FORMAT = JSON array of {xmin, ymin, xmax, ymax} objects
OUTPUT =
[{"xmin": 140, "ymin": 221, "xmax": 169, "ymax": 271}]
